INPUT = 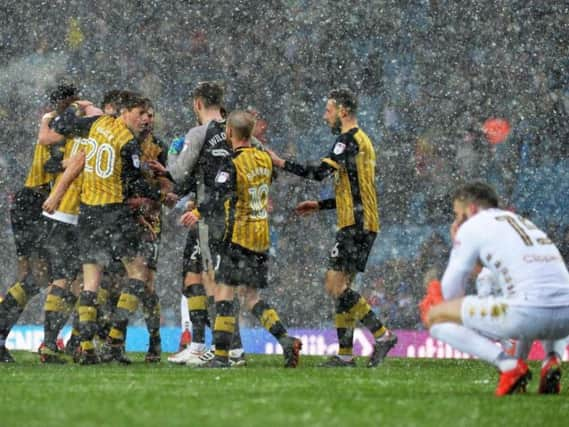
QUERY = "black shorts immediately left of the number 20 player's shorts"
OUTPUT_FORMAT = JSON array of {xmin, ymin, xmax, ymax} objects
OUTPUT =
[{"xmin": 45, "ymin": 219, "xmax": 81, "ymax": 280}]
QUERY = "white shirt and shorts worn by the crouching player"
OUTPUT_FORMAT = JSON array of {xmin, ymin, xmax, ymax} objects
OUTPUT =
[{"xmin": 442, "ymin": 209, "xmax": 569, "ymax": 341}]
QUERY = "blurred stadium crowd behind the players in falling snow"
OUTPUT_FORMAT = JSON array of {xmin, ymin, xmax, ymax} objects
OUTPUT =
[{"xmin": 0, "ymin": 0, "xmax": 569, "ymax": 328}]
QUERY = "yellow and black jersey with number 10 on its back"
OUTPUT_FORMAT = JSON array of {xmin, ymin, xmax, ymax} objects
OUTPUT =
[{"xmin": 199, "ymin": 147, "xmax": 273, "ymax": 253}]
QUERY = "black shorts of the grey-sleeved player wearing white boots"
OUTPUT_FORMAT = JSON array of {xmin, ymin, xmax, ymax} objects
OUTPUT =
[{"xmin": 182, "ymin": 224, "xmax": 223, "ymax": 276}]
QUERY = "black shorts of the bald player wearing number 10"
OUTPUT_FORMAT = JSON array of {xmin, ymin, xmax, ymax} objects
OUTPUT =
[{"xmin": 216, "ymin": 243, "xmax": 269, "ymax": 289}]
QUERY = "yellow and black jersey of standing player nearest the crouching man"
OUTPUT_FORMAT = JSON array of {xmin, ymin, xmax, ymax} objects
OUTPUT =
[{"xmin": 284, "ymin": 127, "xmax": 379, "ymax": 233}]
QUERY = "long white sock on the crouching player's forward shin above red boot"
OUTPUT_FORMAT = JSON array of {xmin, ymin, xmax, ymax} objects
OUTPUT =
[{"xmin": 430, "ymin": 322, "xmax": 504, "ymax": 370}]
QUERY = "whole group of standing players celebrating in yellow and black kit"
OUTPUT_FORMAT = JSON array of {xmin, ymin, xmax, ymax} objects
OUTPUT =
[{"xmin": 0, "ymin": 82, "xmax": 397, "ymax": 367}]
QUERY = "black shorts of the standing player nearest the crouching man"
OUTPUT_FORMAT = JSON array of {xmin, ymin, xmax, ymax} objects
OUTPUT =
[{"xmin": 328, "ymin": 227, "xmax": 377, "ymax": 273}]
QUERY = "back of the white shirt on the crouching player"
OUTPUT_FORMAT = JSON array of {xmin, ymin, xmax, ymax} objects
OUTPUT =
[{"xmin": 464, "ymin": 209, "xmax": 569, "ymax": 306}]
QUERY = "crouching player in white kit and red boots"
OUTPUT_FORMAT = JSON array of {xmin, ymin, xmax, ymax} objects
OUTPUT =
[{"xmin": 427, "ymin": 183, "xmax": 569, "ymax": 396}]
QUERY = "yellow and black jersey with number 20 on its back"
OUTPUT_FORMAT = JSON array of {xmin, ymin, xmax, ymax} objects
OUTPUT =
[{"xmin": 50, "ymin": 107, "xmax": 160, "ymax": 206}]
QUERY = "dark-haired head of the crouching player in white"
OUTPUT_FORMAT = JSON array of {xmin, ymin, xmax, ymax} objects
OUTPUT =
[{"xmin": 452, "ymin": 182, "xmax": 500, "ymax": 225}]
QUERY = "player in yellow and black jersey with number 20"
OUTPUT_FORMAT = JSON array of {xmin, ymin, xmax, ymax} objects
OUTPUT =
[{"xmin": 44, "ymin": 92, "xmax": 161, "ymax": 364}]
